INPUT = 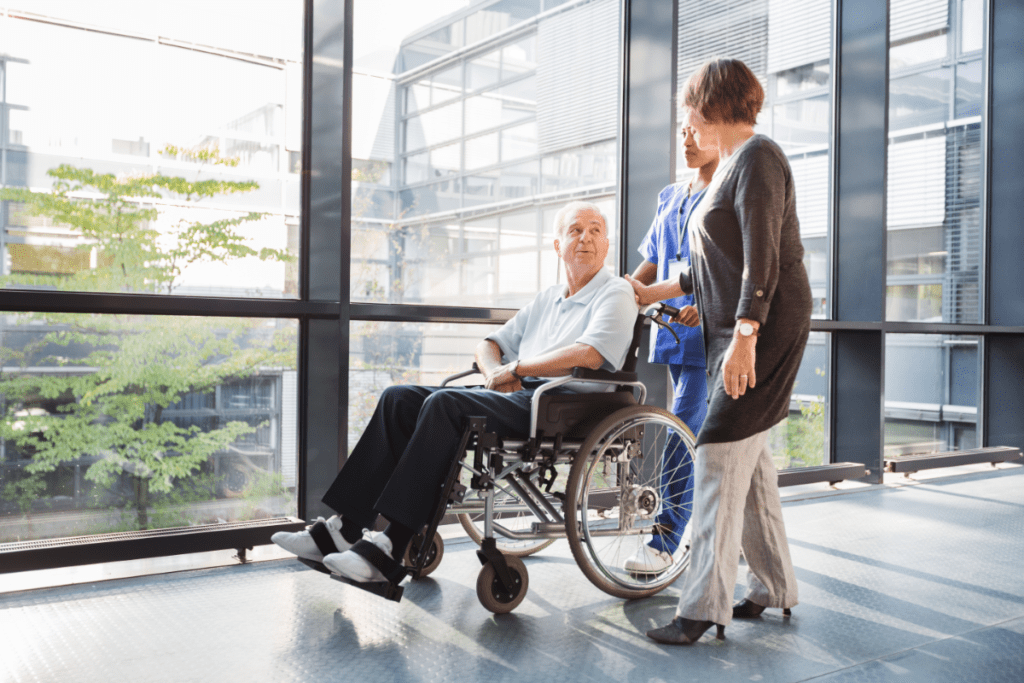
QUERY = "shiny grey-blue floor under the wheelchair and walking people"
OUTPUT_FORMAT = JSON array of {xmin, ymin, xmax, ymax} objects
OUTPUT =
[{"xmin": 0, "ymin": 467, "xmax": 1024, "ymax": 683}]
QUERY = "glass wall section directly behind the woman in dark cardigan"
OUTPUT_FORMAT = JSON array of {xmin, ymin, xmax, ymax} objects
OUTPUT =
[{"xmin": 676, "ymin": 0, "xmax": 833, "ymax": 467}]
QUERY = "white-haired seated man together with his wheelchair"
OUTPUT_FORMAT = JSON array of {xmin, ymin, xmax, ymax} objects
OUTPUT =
[{"xmin": 272, "ymin": 202, "xmax": 693, "ymax": 612}]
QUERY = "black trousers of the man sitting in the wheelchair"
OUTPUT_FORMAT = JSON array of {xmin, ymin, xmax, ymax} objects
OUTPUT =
[{"xmin": 324, "ymin": 386, "xmax": 563, "ymax": 530}]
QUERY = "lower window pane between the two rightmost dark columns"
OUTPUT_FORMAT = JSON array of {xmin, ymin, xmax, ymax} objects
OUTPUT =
[{"xmin": 885, "ymin": 334, "xmax": 979, "ymax": 458}]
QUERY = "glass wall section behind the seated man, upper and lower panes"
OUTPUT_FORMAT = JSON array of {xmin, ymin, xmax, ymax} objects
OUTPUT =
[{"xmin": 349, "ymin": 0, "xmax": 621, "ymax": 428}]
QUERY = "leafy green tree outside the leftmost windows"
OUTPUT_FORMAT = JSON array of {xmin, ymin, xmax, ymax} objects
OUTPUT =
[{"xmin": 0, "ymin": 146, "xmax": 295, "ymax": 528}]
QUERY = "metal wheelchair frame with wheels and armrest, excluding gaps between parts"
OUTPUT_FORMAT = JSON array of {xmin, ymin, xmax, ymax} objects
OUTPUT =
[{"xmin": 391, "ymin": 304, "xmax": 694, "ymax": 613}]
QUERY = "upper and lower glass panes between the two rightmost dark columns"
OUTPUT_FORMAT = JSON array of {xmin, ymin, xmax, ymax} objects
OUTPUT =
[{"xmin": 886, "ymin": 0, "xmax": 986, "ymax": 455}]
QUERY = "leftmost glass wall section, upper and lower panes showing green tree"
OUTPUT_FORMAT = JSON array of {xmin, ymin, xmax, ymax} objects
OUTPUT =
[{"xmin": 0, "ymin": 0, "xmax": 304, "ymax": 543}]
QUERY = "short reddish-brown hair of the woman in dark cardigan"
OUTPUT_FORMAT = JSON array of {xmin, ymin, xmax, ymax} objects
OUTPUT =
[{"xmin": 682, "ymin": 58, "xmax": 765, "ymax": 126}]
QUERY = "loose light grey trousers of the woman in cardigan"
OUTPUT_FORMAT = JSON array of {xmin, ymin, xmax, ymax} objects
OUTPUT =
[{"xmin": 676, "ymin": 431, "xmax": 797, "ymax": 625}]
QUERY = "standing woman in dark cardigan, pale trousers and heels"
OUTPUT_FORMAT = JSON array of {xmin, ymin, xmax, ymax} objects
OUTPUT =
[{"xmin": 631, "ymin": 59, "xmax": 811, "ymax": 644}]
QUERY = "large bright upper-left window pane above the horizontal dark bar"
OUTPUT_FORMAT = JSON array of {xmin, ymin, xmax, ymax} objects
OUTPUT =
[{"xmin": 0, "ymin": 5, "xmax": 304, "ymax": 298}]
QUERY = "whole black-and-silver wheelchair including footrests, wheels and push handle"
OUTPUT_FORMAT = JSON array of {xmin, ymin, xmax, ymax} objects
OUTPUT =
[{"xmin": 321, "ymin": 304, "xmax": 695, "ymax": 613}]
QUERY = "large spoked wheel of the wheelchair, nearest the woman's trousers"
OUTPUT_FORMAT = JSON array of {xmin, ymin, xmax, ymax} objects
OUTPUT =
[{"xmin": 565, "ymin": 405, "xmax": 695, "ymax": 599}]
